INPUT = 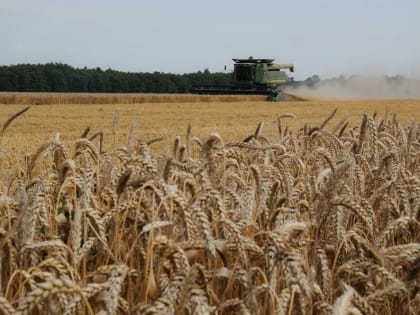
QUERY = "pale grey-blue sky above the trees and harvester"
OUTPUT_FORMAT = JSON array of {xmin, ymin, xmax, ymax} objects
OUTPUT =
[{"xmin": 0, "ymin": 0, "xmax": 420, "ymax": 80}]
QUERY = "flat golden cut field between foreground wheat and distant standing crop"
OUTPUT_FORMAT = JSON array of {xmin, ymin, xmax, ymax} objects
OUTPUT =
[{"xmin": 0, "ymin": 95, "xmax": 420, "ymax": 160}]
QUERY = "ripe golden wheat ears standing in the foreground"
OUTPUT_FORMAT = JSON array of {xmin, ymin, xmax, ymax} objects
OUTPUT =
[{"xmin": 0, "ymin": 107, "xmax": 420, "ymax": 314}]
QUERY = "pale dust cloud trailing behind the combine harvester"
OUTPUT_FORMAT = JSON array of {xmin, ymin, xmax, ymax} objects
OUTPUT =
[{"xmin": 285, "ymin": 76, "xmax": 420, "ymax": 100}]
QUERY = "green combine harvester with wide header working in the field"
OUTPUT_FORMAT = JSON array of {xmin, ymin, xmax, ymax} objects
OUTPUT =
[{"xmin": 190, "ymin": 57, "xmax": 294, "ymax": 101}]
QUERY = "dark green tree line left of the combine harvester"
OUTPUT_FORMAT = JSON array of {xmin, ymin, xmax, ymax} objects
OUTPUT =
[{"xmin": 0, "ymin": 63, "xmax": 231, "ymax": 93}]
